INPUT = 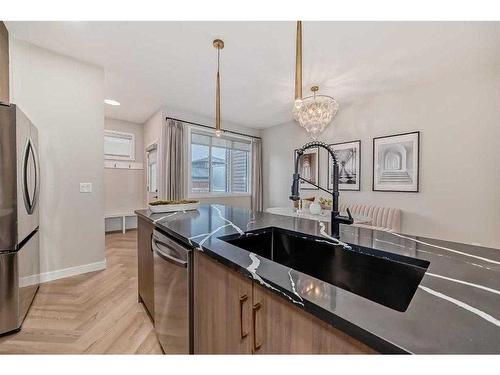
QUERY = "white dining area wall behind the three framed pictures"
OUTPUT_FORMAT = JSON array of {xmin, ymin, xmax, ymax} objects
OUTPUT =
[{"xmin": 263, "ymin": 69, "xmax": 500, "ymax": 248}]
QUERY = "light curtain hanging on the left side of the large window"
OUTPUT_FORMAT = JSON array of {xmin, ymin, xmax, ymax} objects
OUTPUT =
[{"xmin": 158, "ymin": 119, "xmax": 186, "ymax": 200}]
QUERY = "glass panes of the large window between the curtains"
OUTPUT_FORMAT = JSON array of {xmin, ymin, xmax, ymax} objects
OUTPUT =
[{"xmin": 189, "ymin": 129, "xmax": 251, "ymax": 195}]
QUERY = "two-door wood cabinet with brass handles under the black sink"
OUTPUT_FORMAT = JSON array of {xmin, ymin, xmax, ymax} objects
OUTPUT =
[{"xmin": 194, "ymin": 252, "xmax": 374, "ymax": 354}]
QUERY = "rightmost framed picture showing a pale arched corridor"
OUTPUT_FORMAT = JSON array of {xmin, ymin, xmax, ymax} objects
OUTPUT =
[{"xmin": 373, "ymin": 131, "xmax": 420, "ymax": 193}]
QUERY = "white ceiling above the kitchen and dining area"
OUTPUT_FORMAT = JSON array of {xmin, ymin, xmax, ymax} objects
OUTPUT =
[{"xmin": 6, "ymin": 22, "xmax": 500, "ymax": 128}]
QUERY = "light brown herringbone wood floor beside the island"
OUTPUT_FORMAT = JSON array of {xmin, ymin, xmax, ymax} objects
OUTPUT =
[{"xmin": 0, "ymin": 231, "xmax": 161, "ymax": 354}]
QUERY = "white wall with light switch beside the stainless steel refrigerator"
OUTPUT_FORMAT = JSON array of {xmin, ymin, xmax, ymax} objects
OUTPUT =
[{"xmin": 10, "ymin": 38, "xmax": 105, "ymax": 280}]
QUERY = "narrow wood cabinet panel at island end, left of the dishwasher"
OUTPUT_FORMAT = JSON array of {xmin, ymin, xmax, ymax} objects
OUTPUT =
[{"xmin": 137, "ymin": 216, "xmax": 155, "ymax": 319}]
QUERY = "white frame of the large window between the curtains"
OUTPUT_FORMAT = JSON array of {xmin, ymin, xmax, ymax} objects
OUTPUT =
[{"xmin": 186, "ymin": 125, "xmax": 252, "ymax": 198}]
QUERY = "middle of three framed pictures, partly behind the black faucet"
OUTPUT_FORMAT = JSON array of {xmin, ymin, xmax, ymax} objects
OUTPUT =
[{"xmin": 328, "ymin": 140, "xmax": 361, "ymax": 191}]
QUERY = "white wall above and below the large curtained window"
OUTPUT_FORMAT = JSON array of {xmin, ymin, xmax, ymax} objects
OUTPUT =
[{"xmin": 144, "ymin": 107, "xmax": 260, "ymax": 208}]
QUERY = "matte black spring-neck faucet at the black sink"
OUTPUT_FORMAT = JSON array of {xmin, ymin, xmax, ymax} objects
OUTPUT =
[{"xmin": 290, "ymin": 141, "xmax": 354, "ymax": 239}]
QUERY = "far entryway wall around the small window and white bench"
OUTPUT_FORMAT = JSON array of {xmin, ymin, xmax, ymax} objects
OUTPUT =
[{"xmin": 104, "ymin": 118, "xmax": 146, "ymax": 231}]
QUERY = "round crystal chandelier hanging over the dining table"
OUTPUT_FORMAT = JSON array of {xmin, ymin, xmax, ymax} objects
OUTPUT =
[{"xmin": 293, "ymin": 86, "xmax": 339, "ymax": 137}]
